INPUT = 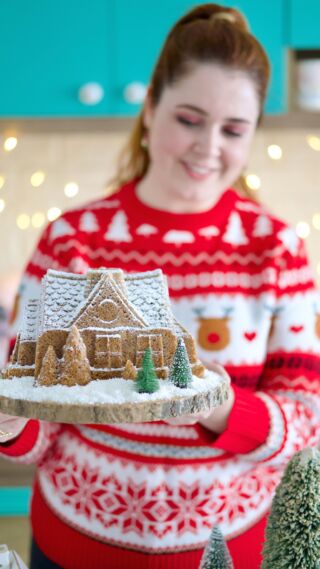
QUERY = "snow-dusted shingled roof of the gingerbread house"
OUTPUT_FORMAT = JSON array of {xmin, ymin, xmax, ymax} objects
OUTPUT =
[{"xmin": 21, "ymin": 269, "xmax": 181, "ymax": 341}]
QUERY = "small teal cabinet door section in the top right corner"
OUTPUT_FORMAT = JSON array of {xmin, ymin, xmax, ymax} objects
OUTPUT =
[{"xmin": 288, "ymin": 0, "xmax": 320, "ymax": 49}]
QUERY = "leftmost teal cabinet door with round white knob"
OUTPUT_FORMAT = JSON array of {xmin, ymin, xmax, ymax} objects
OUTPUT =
[{"xmin": 0, "ymin": 0, "xmax": 111, "ymax": 117}]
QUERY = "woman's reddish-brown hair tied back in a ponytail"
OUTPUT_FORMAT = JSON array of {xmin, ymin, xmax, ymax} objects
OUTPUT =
[{"xmin": 113, "ymin": 4, "xmax": 270, "ymax": 197}]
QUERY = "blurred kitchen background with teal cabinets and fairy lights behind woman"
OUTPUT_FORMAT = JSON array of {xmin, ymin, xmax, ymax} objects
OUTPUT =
[{"xmin": 0, "ymin": 0, "xmax": 320, "ymax": 560}]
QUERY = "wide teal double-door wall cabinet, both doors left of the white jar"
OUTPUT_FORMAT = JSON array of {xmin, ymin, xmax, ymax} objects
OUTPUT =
[{"xmin": 0, "ymin": 0, "xmax": 288, "ymax": 118}]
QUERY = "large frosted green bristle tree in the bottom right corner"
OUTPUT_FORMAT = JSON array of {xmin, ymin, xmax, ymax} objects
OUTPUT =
[{"xmin": 261, "ymin": 448, "xmax": 320, "ymax": 569}]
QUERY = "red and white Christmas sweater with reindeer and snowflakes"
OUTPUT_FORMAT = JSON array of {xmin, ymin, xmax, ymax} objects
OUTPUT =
[{"xmin": 1, "ymin": 182, "xmax": 320, "ymax": 569}]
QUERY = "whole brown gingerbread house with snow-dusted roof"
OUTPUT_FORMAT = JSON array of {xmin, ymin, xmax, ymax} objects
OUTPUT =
[{"xmin": 5, "ymin": 269, "xmax": 204, "ymax": 383}]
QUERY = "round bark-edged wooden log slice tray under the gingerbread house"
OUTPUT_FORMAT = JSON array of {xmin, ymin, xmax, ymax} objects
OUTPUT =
[{"xmin": 0, "ymin": 366, "xmax": 230, "ymax": 424}]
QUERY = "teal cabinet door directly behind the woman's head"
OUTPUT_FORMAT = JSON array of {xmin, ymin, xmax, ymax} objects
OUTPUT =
[{"xmin": 111, "ymin": 0, "xmax": 286, "ymax": 115}]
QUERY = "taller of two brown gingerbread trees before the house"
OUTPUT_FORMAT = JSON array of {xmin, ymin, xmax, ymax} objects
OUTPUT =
[{"xmin": 60, "ymin": 326, "xmax": 91, "ymax": 386}]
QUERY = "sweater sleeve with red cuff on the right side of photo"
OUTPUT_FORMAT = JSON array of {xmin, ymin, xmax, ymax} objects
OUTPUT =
[{"xmin": 214, "ymin": 237, "xmax": 320, "ymax": 464}]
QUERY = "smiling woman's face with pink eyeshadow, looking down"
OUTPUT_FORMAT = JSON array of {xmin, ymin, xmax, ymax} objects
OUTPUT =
[{"xmin": 144, "ymin": 63, "xmax": 260, "ymax": 212}]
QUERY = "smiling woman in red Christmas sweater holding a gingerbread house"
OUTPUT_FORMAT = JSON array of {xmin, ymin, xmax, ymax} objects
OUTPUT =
[{"xmin": 0, "ymin": 4, "xmax": 319, "ymax": 569}]
